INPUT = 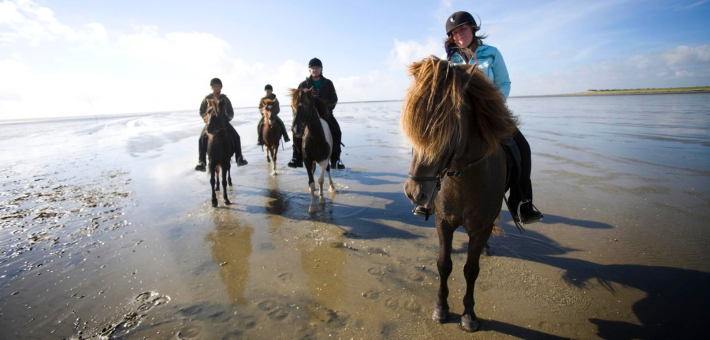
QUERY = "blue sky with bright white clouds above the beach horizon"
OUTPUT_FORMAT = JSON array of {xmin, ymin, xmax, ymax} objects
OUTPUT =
[{"xmin": 0, "ymin": 0, "xmax": 710, "ymax": 120}]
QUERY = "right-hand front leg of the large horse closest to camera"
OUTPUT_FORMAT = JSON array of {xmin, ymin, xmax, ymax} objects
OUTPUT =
[{"xmin": 460, "ymin": 228, "xmax": 491, "ymax": 332}]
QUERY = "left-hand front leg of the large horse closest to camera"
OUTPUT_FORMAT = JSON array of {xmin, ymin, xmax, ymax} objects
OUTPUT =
[{"xmin": 432, "ymin": 219, "xmax": 455, "ymax": 323}]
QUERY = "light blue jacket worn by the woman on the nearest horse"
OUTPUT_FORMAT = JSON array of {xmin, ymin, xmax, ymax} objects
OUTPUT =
[{"xmin": 449, "ymin": 45, "xmax": 510, "ymax": 100}]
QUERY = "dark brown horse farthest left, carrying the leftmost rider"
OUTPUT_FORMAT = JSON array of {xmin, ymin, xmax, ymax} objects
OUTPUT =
[{"xmin": 205, "ymin": 97, "xmax": 234, "ymax": 207}]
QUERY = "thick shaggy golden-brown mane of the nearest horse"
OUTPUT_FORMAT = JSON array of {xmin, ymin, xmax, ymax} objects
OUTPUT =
[{"xmin": 400, "ymin": 56, "xmax": 518, "ymax": 164}]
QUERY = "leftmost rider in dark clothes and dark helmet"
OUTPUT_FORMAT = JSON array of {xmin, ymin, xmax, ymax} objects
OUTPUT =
[{"xmin": 195, "ymin": 78, "xmax": 249, "ymax": 171}]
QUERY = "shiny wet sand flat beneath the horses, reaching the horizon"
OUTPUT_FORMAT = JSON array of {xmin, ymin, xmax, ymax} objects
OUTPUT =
[{"xmin": 0, "ymin": 95, "xmax": 710, "ymax": 339}]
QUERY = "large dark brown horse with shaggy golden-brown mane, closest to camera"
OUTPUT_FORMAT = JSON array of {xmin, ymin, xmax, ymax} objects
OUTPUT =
[{"xmin": 400, "ymin": 56, "xmax": 517, "ymax": 332}]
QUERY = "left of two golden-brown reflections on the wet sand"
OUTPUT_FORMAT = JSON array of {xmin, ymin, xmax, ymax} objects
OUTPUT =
[{"xmin": 205, "ymin": 209, "xmax": 254, "ymax": 304}]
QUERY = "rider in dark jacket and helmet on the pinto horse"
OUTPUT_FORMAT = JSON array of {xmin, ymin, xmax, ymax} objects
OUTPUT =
[{"xmin": 288, "ymin": 58, "xmax": 345, "ymax": 170}]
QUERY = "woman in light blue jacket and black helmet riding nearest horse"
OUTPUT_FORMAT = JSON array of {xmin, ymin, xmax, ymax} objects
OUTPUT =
[{"xmin": 444, "ymin": 11, "xmax": 543, "ymax": 224}]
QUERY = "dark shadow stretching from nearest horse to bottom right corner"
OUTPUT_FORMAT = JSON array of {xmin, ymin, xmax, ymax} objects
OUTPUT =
[{"xmin": 492, "ymin": 216, "xmax": 710, "ymax": 339}]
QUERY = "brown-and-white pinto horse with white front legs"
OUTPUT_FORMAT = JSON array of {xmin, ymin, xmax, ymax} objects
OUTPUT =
[{"xmin": 291, "ymin": 89, "xmax": 335, "ymax": 213}]
